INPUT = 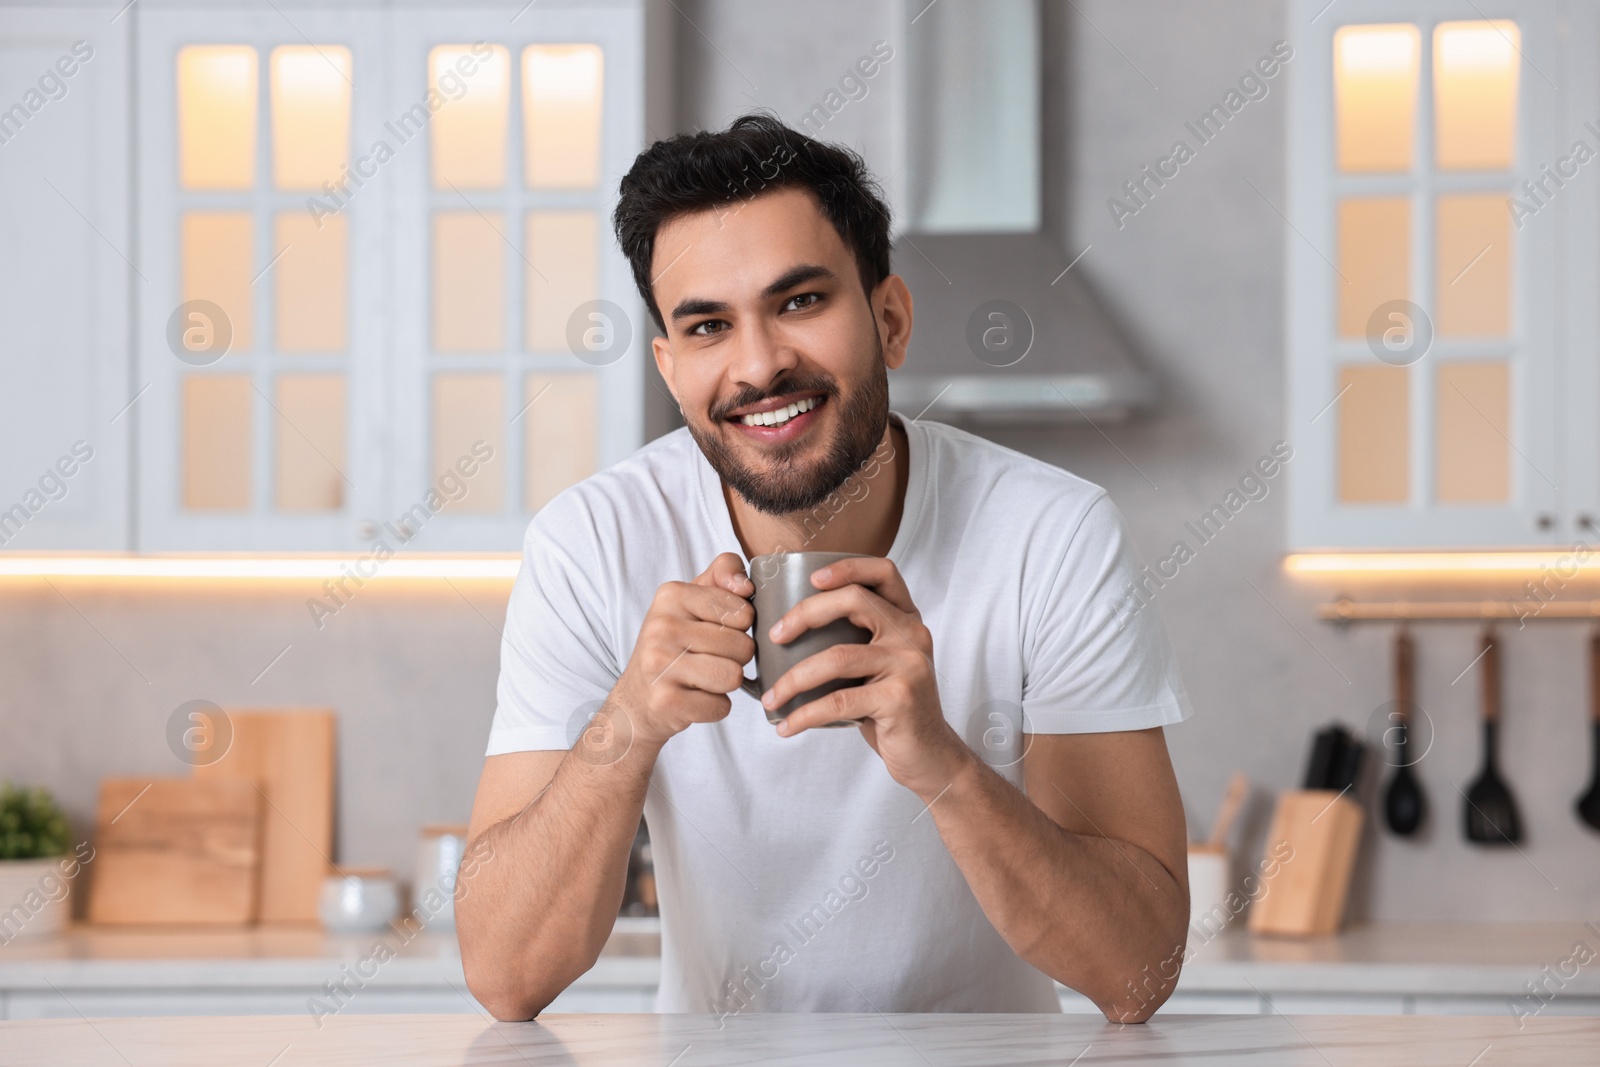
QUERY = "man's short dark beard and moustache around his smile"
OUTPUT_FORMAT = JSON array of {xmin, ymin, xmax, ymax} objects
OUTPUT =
[{"xmin": 683, "ymin": 331, "xmax": 890, "ymax": 515}]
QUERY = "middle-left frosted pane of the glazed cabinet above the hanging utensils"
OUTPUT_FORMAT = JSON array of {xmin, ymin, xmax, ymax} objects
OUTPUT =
[{"xmin": 1333, "ymin": 197, "xmax": 1411, "ymax": 338}]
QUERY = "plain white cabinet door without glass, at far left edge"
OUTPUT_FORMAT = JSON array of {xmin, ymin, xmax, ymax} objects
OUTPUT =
[{"xmin": 0, "ymin": 6, "xmax": 129, "ymax": 550}]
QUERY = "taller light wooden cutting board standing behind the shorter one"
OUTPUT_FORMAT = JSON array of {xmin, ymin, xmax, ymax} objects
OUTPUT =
[{"xmin": 195, "ymin": 709, "xmax": 334, "ymax": 923}]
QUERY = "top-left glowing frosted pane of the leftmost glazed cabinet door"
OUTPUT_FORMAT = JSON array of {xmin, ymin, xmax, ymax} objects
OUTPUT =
[{"xmin": 178, "ymin": 45, "xmax": 258, "ymax": 189}]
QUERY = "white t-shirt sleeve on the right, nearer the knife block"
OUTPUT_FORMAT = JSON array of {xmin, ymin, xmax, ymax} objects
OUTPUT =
[{"xmin": 1022, "ymin": 493, "xmax": 1192, "ymax": 734}]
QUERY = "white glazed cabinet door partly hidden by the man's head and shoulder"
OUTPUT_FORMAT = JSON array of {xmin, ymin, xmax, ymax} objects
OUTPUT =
[{"xmin": 378, "ymin": 5, "xmax": 648, "ymax": 552}]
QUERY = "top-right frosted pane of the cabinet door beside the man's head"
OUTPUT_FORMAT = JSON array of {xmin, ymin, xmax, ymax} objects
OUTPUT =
[{"xmin": 522, "ymin": 45, "xmax": 605, "ymax": 189}]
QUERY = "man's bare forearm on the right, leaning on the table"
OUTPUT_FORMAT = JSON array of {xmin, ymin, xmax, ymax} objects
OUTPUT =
[{"xmin": 923, "ymin": 753, "xmax": 1187, "ymax": 1022}]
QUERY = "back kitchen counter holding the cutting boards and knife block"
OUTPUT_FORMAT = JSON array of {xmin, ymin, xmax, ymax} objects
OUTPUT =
[{"xmin": 0, "ymin": 918, "xmax": 1600, "ymax": 1019}]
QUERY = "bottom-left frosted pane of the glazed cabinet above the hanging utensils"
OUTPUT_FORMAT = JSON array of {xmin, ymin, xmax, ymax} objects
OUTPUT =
[{"xmin": 1338, "ymin": 365, "xmax": 1411, "ymax": 504}]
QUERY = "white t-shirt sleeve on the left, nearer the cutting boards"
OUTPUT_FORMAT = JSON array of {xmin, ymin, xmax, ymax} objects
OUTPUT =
[{"xmin": 488, "ymin": 494, "xmax": 621, "ymax": 755}]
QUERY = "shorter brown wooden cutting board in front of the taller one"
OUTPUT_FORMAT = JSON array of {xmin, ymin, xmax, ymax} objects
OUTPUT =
[{"xmin": 88, "ymin": 777, "xmax": 261, "ymax": 925}]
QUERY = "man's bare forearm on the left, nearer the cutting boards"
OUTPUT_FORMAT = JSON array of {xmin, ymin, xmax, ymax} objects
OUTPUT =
[{"xmin": 456, "ymin": 710, "xmax": 659, "ymax": 1019}]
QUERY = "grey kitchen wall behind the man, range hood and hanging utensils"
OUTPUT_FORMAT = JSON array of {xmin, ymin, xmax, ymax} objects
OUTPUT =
[{"xmin": 0, "ymin": 0, "xmax": 1600, "ymax": 920}]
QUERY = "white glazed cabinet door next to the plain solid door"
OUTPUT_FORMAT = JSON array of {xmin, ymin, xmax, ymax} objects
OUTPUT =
[{"xmin": 136, "ymin": 6, "xmax": 389, "ymax": 550}]
